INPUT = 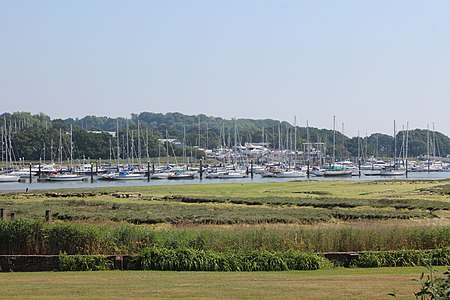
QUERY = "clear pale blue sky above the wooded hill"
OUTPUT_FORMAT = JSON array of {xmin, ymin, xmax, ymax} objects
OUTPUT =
[{"xmin": 0, "ymin": 0, "xmax": 450, "ymax": 136}]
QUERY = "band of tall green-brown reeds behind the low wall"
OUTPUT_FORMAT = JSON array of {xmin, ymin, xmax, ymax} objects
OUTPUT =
[{"xmin": 0, "ymin": 218, "xmax": 450, "ymax": 255}]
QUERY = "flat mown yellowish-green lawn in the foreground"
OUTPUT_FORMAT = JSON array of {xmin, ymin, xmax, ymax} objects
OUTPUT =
[{"xmin": 0, "ymin": 267, "xmax": 446, "ymax": 299}]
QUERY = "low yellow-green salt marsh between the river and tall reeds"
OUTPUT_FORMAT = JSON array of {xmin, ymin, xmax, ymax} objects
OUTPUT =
[{"xmin": 0, "ymin": 181, "xmax": 450, "ymax": 224}]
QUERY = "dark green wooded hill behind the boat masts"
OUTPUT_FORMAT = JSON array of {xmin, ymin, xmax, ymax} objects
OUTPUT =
[{"xmin": 0, "ymin": 112, "xmax": 450, "ymax": 161}]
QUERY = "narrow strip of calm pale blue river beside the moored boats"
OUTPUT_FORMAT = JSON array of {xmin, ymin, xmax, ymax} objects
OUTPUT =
[{"xmin": 0, "ymin": 172, "xmax": 450, "ymax": 191}]
